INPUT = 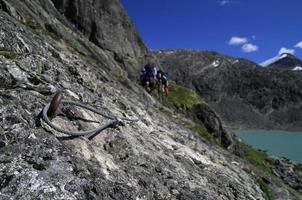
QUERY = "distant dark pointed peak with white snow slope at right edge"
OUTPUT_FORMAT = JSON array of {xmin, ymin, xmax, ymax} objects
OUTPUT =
[{"xmin": 260, "ymin": 53, "xmax": 302, "ymax": 71}]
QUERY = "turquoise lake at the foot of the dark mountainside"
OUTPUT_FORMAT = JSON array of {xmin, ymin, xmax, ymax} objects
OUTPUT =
[{"xmin": 236, "ymin": 130, "xmax": 302, "ymax": 164}]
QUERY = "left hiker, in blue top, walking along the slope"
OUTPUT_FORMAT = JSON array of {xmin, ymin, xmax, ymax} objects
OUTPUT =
[{"xmin": 141, "ymin": 63, "xmax": 157, "ymax": 93}]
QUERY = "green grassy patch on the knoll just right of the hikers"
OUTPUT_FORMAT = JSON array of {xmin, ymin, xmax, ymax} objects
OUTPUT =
[{"xmin": 168, "ymin": 83, "xmax": 205, "ymax": 109}]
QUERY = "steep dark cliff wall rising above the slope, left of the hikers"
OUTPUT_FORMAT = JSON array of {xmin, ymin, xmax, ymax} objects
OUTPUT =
[{"xmin": 52, "ymin": 0, "xmax": 148, "ymax": 76}]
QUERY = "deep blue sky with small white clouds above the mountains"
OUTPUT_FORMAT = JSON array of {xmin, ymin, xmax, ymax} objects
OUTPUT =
[{"xmin": 121, "ymin": 0, "xmax": 302, "ymax": 63}]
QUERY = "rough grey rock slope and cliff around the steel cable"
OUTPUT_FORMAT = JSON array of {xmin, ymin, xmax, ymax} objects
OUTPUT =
[{"xmin": 0, "ymin": 0, "xmax": 301, "ymax": 200}]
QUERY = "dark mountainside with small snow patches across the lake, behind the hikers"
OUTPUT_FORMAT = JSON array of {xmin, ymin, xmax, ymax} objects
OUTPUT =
[{"xmin": 154, "ymin": 50, "xmax": 302, "ymax": 130}]
